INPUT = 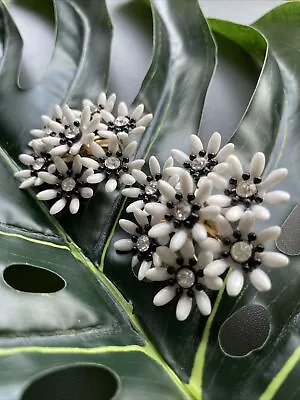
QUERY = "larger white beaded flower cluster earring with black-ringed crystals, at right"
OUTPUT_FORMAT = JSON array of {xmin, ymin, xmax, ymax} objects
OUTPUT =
[{"xmin": 114, "ymin": 133, "xmax": 289, "ymax": 321}]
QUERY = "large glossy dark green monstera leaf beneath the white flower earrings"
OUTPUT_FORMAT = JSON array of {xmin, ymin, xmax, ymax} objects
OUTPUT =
[{"xmin": 0, "ymin": 0, "xmax": 300, "ymax": 400}]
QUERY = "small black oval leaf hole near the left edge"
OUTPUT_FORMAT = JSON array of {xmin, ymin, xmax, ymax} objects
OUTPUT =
[{"xmin": 3, "ymin": 264, "xmax": 66, "ymax": 293}]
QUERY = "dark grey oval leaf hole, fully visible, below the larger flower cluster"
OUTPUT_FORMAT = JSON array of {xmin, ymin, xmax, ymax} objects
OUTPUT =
[{"xmin": 219, "ymin": 304, "xmax": 271, "ymax": 357}]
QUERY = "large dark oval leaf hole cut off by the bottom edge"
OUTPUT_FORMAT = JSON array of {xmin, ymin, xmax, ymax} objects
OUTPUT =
[{"xmin": 21, "ymin": 364, "xmax": 120, "ymax": 400}]
